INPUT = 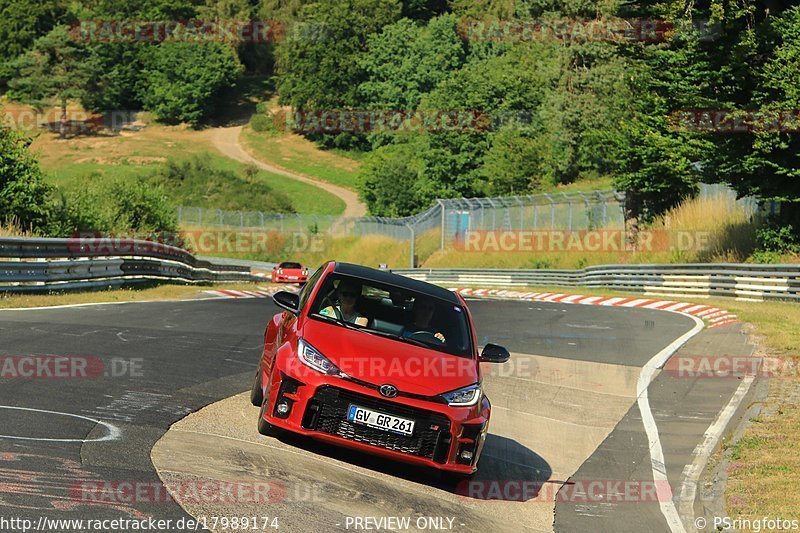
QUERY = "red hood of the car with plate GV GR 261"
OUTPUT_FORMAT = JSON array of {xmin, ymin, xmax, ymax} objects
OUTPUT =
[{"xmin": 302, "ymin": 319, "xmax": 480, "ymax": 396}]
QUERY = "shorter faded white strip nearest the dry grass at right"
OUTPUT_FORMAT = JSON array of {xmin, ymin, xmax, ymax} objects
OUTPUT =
[{"xmin": 680, "ymin": 376, "xmax": 755, "ymax": 519}]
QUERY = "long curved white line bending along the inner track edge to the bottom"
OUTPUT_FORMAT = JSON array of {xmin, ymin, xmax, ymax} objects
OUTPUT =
[{"xmin": 636, "ymin": 314, "xmax": 704, "ymax": 533}]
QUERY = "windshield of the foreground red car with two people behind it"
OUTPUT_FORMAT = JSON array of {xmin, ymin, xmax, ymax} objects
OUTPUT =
[{"xmin": 309, "ymin": 274, "xmax": 472, "ymax": 357}]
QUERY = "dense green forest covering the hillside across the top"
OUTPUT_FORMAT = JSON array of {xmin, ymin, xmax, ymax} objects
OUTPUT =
[{"xmin": 0, "ymin": 0, "xmax": 800, "ymax": 232}]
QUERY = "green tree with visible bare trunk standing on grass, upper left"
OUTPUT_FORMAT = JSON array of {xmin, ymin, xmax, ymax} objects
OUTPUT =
[{"xmin": 8, "ymin": 26, "xmax": 97, "ymax": 137}]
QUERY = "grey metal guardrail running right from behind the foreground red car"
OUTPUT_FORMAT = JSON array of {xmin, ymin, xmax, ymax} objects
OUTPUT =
[{"xmin": 392, "ymin": 263, "xmax": 800, "ymax": 301}]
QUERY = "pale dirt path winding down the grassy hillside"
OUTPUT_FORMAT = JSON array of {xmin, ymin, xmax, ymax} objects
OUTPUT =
[{"xmin": 211, "ymin": 126, "xmax": 367, "ymax": 217}]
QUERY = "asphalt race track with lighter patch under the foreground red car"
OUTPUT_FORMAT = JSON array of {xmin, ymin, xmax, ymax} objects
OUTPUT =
[{"xmin": 0, "ymin": 299, "xmax": 749, "ymax": 531}]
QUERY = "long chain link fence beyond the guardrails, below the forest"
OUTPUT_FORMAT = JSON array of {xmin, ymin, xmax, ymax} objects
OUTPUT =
[{"xmin": 177, "ymin": 184, "xmax": 779, "ymax": 266}]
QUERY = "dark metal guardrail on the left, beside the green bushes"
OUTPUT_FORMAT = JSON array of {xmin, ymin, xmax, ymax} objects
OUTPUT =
[{"xmin": 0, "ymin": 237, "xmax": 263, "ymax": 292}]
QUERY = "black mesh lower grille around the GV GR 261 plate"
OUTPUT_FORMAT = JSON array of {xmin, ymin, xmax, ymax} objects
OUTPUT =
[{"xmin": 303, "ymin": 386, "xmax": 451, "ymax": 463}]
